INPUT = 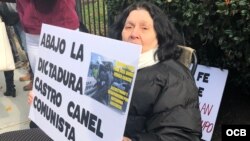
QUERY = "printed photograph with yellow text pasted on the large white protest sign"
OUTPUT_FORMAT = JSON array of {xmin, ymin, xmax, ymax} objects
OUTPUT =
[{"xmin": 85, "ymin": 53, "xmax": 135, "ymax": 113}]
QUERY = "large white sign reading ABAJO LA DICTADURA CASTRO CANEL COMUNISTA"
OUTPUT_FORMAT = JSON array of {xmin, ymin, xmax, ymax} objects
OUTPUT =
[{"xmin": 29, "ymin": 24, "xmax": 141, "ymax": 141}]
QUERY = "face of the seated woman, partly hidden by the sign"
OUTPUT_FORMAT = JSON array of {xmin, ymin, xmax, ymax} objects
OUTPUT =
[{"xmin": 122, "ymin": 9, "xmax": 158, "ymax": 53}]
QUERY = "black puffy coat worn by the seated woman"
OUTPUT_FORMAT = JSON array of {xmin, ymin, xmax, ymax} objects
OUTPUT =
[{"xmin": 124, "ymin": 60, "xmax": 202, "ymax": 141}]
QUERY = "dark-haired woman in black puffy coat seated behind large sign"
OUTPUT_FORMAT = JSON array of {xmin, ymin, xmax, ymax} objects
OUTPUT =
[{"xmin": 110, "ymin": 2, "xmax": 201, "ymax": 141}]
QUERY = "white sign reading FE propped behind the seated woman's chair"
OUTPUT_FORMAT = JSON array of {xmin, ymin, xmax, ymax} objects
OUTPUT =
[{"xmin": 194, "ymin": 65, "xmax": 228, "ymax": 141}]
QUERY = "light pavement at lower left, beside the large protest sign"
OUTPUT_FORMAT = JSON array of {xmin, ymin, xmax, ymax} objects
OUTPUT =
[{"xmin": 0, "ymin": 68, "xmax": 30, "ymax": 134}]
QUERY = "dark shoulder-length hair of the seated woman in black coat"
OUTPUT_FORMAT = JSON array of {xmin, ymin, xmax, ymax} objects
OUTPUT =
[{"xmin": 109, "ymin": 1, "xmax": 181, "ymax": 62}]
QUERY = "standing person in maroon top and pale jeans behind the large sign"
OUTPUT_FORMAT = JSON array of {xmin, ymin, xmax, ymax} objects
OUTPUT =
[{"xmin": 0, "ymin": 0, "xmax": 79, "ymax": 79}]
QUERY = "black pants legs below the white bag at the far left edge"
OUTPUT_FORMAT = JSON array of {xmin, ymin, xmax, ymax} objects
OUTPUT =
[{"xmin": 4, "ymin": 70, "xmax": 16, "ymax": 92}]
